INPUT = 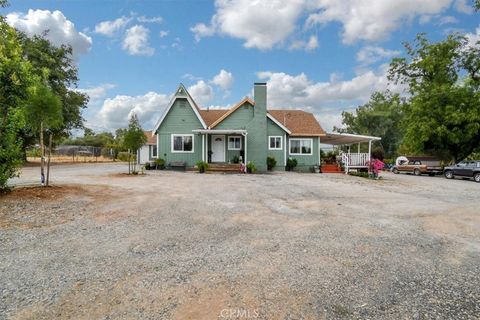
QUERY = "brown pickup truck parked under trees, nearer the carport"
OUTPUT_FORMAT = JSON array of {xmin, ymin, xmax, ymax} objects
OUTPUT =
[{"xmin": 392, "ymin": 157, "xmax": 443, "ymax": 176}]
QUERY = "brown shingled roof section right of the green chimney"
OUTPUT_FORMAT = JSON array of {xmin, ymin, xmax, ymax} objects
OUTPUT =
[{"xmin": 267, "ymin": 110, "xmax": 325, "ymax": 137}]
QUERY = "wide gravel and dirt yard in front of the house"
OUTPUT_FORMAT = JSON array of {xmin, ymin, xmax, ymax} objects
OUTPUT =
[{"xmin": 0, "ymin": 163, "xmax": 480, "ymax": 319}]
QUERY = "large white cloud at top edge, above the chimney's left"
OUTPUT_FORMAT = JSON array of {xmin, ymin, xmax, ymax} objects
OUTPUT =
[{"xmin": 191, "ymin": 0, "xmax": 305, "ymax": 50}]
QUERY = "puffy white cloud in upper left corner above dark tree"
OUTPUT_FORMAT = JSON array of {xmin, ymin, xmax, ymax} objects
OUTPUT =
[{"xmin": 7, "ymin": 9, "xmax": 92, "ymax": 60}]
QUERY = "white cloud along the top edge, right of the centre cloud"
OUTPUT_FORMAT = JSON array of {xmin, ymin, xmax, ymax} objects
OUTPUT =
[{"xmin": 307, "ymin": 0, "xmax": 452, "ymax": 44}]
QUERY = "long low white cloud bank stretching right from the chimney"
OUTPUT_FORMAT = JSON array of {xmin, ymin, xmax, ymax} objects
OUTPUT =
[{"xmin": 257, "ymin": 65, "xmax": 403, "ymax": 130}]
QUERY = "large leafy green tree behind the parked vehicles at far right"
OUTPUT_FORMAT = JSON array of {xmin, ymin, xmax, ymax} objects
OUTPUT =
[{"xmin": 389, "ymin": 34, "xmax": 480, "ymax": 161}]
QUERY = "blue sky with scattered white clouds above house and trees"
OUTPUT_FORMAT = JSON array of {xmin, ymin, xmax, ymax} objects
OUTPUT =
[{"xmin": 2, "ymin": 0, "xmax": 480, "ymax": 131}]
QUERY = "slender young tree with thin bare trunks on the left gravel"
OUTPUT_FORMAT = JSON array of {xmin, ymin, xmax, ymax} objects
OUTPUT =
[{"xmin": 25, "ymin": 83, "xmax": 63, "ymax": 186}]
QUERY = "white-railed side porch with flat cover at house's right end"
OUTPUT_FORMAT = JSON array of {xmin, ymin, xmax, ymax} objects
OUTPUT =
[{"xmin": 321, "ymin": 132, "xmax": 381, "ymax": 174}]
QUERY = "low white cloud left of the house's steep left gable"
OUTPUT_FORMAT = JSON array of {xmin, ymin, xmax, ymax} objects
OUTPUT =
[{"xmin": 96, "ymin": 92, "xmax": 170, "ymax": 130}]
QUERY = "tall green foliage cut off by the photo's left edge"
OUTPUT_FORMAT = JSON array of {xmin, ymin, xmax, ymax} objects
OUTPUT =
[{"xmin": 0, "ymin": 21, "xmax": 33, "ymax": 191}]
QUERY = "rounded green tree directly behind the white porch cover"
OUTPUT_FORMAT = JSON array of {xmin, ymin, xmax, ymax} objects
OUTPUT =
[{"xmin": 334, "ymin": 91, "xmax": 406, "ymax": 157}]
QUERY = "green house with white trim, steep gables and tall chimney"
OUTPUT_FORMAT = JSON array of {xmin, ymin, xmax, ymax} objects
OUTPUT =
[{"xmin": 152, "ymin": 83, "xmax": 325, "ymax": 172}]
